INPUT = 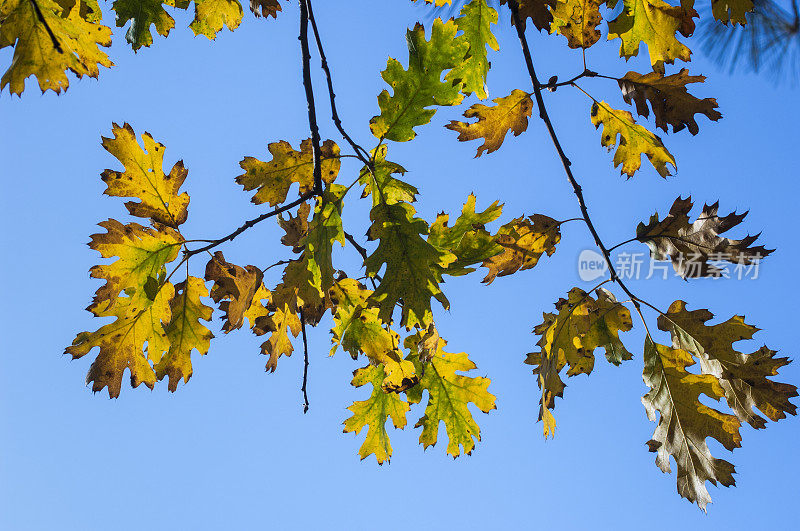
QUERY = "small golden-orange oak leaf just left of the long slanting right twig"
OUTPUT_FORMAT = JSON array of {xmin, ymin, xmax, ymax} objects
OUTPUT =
[{"xmin": 445, "ymin": 89, "xmax": 533, "ymax": 157}]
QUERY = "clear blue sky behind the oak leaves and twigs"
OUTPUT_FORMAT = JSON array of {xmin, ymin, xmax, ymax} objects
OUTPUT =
[{"xmin": 0, "ymin": 0, "xmax": 800, "ymax": 531}]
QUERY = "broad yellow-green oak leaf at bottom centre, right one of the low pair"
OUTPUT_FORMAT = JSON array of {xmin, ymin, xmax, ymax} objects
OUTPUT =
[{"xmin": 404, "ymin": 330, "xmax": 496, "ymax": 458}]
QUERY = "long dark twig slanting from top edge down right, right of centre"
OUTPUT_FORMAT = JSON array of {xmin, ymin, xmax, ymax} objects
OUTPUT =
[{"xmin": 508, "ymin": 0, "xmax": 646, "ymax": 326}]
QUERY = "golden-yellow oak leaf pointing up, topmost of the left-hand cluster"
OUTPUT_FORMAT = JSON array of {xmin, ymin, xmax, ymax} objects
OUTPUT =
[{"xmin": 102, "ymin": 124, "xmax": 189, "ymax": 228}]
